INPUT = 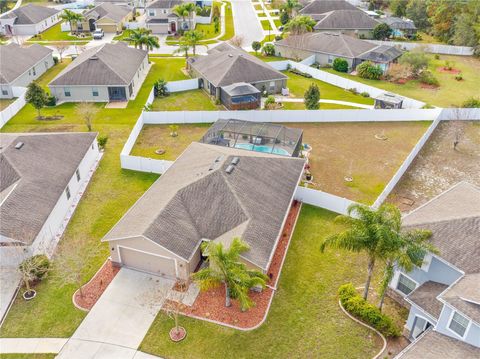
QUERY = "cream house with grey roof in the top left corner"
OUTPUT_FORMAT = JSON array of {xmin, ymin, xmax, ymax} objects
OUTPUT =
[{"xmin": 0, "ymin": 4, "xmax": 61, "ymax": 36}]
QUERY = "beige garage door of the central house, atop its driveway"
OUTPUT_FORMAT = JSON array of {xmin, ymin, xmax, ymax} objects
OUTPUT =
[{"xmin": 118, "ymin": 247, "xmax": 176, "ymax": 278}]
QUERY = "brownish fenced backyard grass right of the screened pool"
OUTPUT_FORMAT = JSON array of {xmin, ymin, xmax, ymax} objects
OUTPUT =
[{"xmin": 285, "ymin": 122, "xmax": 430, "ymax": 204}]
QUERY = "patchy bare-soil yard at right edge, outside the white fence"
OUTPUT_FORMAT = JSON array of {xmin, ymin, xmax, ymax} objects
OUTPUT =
[{"xmin": 387, "ymin": 121, "xmax": 480, "ymax": 211}]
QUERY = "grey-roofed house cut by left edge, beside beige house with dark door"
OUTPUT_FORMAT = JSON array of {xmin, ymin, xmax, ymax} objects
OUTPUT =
[{"xmin": 0, "ymin": 43, "xmax": 54, "ymax": 98}]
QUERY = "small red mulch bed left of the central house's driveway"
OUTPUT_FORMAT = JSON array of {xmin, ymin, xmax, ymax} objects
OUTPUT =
[{"xmin": 74, "ymin": 259, "xmax": 120, "ymax": 310}]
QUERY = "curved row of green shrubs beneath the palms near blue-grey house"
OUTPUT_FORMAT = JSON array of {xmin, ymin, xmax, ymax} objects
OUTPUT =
[{"xmin": 338, "ymin": 283, "xmax": 401, "ymax": 337}]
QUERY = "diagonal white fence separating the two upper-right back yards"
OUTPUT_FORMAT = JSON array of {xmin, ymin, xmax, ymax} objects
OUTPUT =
[{"xmin": 268, "ymin": 60, "xmax": 425, "ymax": 109}]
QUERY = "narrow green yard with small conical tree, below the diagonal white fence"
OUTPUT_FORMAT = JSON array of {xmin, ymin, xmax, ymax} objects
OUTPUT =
[{"xmin": 283, "ymin": 71, "xmax": 373, "ymax": 105}]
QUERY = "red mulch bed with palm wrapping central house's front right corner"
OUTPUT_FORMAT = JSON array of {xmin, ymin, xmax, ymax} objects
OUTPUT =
[{"xmin": 182, "ymin": 201, "xmax": 301, "ymax": 329}]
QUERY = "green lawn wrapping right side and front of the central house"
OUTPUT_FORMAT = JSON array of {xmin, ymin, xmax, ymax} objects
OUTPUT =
[{"xmin": 140, "ymin": 205, "xmax": 381, "ymax": 359}]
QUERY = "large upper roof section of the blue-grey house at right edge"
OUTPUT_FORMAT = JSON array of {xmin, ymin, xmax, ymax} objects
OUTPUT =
[{"xmin": 403, "ymin": 182, "xmax": 480, "ymax": 274}]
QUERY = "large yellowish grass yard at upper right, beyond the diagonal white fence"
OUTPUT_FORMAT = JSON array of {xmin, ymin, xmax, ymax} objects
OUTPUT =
[{"xmin": 324, "ymin": 55, "xmax": 480, "ymax": 107}]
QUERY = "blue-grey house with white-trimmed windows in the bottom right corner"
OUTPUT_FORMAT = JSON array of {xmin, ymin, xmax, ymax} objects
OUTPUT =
[{"xmin": 390, "ymin": 182, "xmax": 480, "ymax": 358}]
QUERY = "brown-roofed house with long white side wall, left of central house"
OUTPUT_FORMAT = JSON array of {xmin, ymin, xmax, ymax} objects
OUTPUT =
[{"xmin": 0, "ymin": 133, "xmax": 100, "ymax": 266}]
